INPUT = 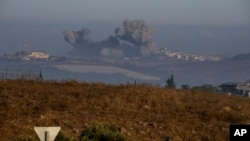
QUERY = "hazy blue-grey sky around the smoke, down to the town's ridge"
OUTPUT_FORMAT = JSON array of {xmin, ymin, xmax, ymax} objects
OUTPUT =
[{"xmin": 0, "ymin": 0, "xmax": 250, "ymax": 55}]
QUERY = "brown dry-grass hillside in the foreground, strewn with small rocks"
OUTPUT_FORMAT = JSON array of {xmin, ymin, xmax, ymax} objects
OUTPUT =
[{"xmin": 0, "ymin": 80, "xmax": 250, "ymax": 141}]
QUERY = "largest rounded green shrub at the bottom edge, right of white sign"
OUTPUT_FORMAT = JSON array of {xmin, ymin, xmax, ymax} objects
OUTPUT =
[{"xmin": 80, "ymin": 123, "xmax": 126, "ymax": 141}]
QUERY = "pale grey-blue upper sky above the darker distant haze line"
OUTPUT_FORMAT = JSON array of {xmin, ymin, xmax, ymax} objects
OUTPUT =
[{"xmin": 0, "ymin": 0, "xmax": 250, "ymax": 25}]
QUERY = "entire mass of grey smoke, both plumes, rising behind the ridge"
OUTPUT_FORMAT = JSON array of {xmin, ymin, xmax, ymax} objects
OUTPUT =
[{"xmin": 63, "ymin": 20, "xmax": 159, "ymax": 57}]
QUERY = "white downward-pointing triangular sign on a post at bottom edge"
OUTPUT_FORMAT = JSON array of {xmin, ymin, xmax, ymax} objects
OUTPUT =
[{"xmin": 34, "ymin": 127, "xmax": 61, "ymax": 141}]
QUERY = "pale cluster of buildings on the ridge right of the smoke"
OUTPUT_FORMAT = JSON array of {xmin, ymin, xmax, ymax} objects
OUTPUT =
[{"xmin": 161, "ymin": 48, "xmax": 220, "ymax": 61}]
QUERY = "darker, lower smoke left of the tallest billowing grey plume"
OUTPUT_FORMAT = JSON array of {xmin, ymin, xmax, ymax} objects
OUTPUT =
[{"xmin": 63, "ymin": 28, "xmax": 123, "ymax": 58}]
